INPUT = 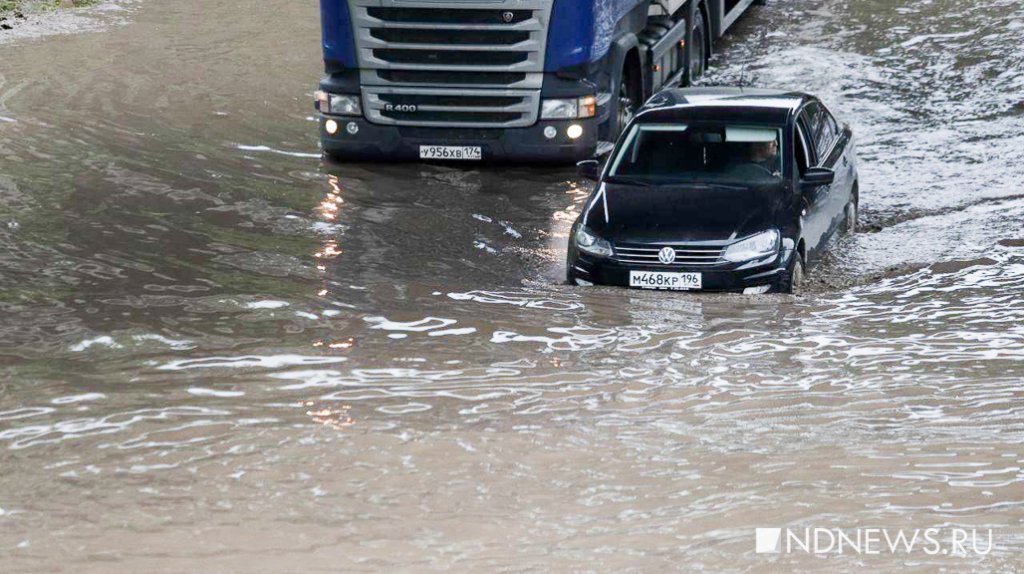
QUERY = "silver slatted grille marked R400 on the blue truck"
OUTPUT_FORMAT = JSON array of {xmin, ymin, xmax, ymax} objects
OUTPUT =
[{"xmin": 349, "ymin": 0, "xmax": 553, "ymax": 128}]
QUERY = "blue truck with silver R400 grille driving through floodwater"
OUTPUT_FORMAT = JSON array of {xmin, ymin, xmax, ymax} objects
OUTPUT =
[{"xmin": 315, "ymin": 0, "xmax": 754, "ymax": 163}]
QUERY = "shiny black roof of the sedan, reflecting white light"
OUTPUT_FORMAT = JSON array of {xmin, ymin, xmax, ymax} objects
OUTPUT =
[{"xmin": 637, "ymin": 87, "xmax": 813, "ymax": 124}]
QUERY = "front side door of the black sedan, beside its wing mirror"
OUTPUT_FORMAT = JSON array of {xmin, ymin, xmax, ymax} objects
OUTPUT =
[{"xmin": 796, "ymin": 105, "xmax": 831, "ymax": 263}]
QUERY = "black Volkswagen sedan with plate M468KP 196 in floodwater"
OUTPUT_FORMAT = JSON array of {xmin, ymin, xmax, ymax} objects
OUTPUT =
[{"xmin": 567, "ymin": 88, "xmax": 859, "ymax": 294}]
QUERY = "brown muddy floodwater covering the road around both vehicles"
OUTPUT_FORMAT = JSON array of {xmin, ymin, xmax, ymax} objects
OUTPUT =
[{"xmin": 0, "ymin": 0, "xmax": 1024, "ymax": 573}]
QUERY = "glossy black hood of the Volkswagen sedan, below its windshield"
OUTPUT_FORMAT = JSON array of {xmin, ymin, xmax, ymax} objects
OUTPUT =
[{"xmin": 585, "ymin": 184, "xmax": 784, "ymax": 244}]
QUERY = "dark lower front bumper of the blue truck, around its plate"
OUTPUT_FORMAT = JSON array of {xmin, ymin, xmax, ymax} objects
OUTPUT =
[{"xmin": 319, "ymin": 114, "xmax": 597, "ymax": 164}]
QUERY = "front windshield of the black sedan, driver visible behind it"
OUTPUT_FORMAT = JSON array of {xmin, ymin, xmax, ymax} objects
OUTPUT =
[{"xmin": 608, "ymin": 124, "xmax": 782, "ymax": 185}]
